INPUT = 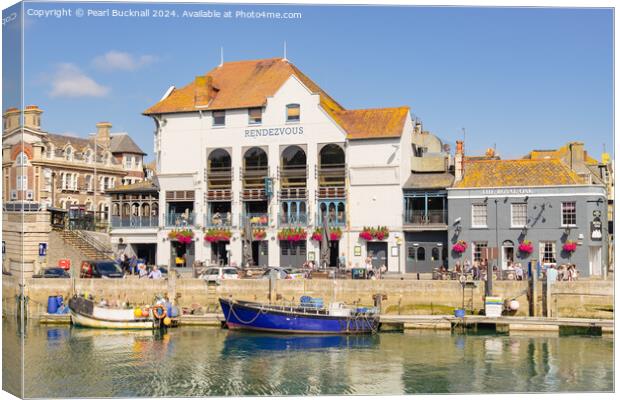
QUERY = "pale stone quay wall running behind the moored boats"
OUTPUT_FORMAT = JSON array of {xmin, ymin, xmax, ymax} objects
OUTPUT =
[{"xmin": 2, "ymin": 275, "xmax": 614, "ymax": 318}]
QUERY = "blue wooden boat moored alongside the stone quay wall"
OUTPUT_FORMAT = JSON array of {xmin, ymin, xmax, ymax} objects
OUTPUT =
[{"xmin": 220, "ymin": 298, "xmax": 379, "ymax": 334}]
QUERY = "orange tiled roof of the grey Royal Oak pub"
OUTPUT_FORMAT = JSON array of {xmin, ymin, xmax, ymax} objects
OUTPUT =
[{"xmin": 454, "ymin": 159, "xmax": 583, "ymax": 188}]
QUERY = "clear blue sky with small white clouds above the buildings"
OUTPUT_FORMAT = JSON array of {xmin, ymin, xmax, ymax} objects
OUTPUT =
[{"xmin": 5, "ymin": 3, "xmax": 613, "ymax": 158}]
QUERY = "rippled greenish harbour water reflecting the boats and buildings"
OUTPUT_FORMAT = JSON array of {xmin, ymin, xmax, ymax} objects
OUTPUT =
[{"xmin": 2, "ymin": 320, "xmax": 613, "ymax": 397}]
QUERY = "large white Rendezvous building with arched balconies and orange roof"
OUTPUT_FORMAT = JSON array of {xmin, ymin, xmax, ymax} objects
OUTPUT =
[{"xmin": 144, "ymin": 58, "xmax": 413, "ymax": 272}]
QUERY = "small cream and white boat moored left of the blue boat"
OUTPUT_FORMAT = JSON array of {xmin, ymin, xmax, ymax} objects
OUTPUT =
[{"xmin": 69, "ymin": 296, "xmax": 156, "ymax": 329}]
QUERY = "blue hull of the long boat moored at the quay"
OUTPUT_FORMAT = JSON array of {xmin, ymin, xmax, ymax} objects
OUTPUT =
[{"xmin": 220, "ymin": 299, "xmax": 379, "ymax": 334}]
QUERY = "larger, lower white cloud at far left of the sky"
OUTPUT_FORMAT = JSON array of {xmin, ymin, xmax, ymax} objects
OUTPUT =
[{"xmin": 50, "ymin": 63, "xmax": 110, "ymax": 97}]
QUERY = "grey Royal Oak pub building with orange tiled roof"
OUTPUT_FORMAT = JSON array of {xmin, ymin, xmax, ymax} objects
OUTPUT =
[{"xmin": 448, "ymin": 154, "xmax": 608, "ymax": 277}]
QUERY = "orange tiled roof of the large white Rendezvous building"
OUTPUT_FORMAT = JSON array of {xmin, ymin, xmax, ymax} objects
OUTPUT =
[{"xmin": 144, "ymin": 58, "xmax": 409, "ymax": 139}]
